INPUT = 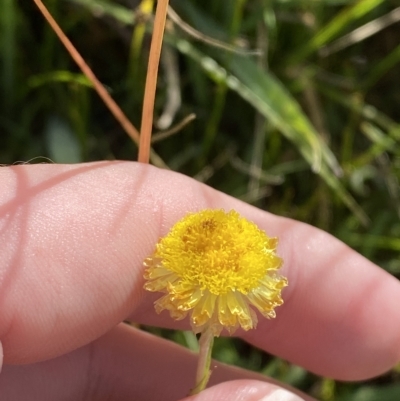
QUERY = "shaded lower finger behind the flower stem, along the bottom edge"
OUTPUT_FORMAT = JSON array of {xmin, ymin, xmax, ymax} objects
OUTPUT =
[{"xmin": 0, "ymin": 325, "xmax": 312, "ymax": 401}]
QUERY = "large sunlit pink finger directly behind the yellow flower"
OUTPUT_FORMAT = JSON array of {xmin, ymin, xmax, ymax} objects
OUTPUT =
[{"xmin": 0, "ymin": 163, "xmax": 400, "ymax": 379}]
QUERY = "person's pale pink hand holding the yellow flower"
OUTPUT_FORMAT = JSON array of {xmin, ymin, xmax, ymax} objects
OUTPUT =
[{"xmin": 0, "ymin": 162, "xmax": 400, "ymax": 401}]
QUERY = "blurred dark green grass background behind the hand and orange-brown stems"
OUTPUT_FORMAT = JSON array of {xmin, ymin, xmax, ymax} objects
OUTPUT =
[{"xmin": 0, "ymin": 0, "xmax": 400, "ymax": 401}]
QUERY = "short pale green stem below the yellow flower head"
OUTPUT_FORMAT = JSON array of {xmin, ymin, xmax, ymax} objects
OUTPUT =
[{"xmin": 189, "ymin": 328, "xmax": 214, "ymax": 395}]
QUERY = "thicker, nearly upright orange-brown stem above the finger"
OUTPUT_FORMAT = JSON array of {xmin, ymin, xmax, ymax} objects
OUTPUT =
[{"xmin": 138, "ymin": 0, "xmax": 169, "ymax": 163}]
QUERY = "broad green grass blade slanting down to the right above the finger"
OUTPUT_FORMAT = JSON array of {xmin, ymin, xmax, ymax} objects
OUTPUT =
[{"xmin": 176, "ymin": 40, "xmax": 368, "ymax": 224}]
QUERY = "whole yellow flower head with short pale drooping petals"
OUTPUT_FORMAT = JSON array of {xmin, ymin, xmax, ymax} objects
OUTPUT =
[{"xmin": 144, "ymin": 210, "xmax": 287, "ymax": 336}]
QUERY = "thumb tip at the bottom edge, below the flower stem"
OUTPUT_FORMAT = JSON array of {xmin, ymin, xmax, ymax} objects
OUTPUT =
[{"xmin": 182, "ymin": 380, "xmax": 306, "ymax": 401}]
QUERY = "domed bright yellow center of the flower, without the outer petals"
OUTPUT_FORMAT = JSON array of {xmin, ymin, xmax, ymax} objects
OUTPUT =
[{"xmin": 157, "ymin": 210, "xmax": 281, "ymax": 295}]
